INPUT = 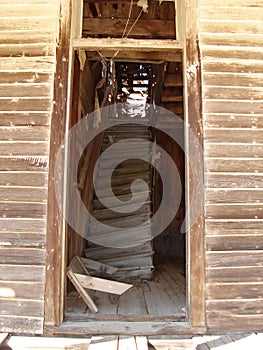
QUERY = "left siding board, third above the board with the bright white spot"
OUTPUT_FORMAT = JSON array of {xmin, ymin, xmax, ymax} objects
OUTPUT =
[{"xmin": 0, "ymin": 232, "xmax": 46, "ymax": 248}]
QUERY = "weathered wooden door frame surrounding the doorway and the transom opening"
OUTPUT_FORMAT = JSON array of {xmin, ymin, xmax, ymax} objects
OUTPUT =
[{"xmin": 44, "ymin": 0, "xmax": 206, "ymax": 334}]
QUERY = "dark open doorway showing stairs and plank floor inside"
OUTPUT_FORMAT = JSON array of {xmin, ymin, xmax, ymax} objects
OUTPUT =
[{"xmin": 66, "ymin": 52, "xmax": 186, "ymax": 320}]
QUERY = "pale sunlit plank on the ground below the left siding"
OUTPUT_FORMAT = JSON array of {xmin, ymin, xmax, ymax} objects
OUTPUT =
[{"xmin": 3, "ymin": 336, "xmax": 90, "ymax": 350}]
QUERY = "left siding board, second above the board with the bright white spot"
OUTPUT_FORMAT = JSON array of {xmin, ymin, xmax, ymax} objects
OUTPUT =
[{"xmin": 0, "ymin": 247, "xmax": 45, "ymax": 266}]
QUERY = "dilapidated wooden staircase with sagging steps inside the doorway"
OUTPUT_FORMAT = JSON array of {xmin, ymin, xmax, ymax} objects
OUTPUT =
[{"xmin": 85, "ymin": 124, "xmax": 153, "ymax": 279}]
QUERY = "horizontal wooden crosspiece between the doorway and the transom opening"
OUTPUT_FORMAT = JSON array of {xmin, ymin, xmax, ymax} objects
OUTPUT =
[{"xmin": 72, "ymin": 38, "xmax": 183, "ymax": 52}]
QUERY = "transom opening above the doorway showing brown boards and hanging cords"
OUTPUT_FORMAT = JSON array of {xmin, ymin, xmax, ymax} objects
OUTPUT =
[{"xmin": 82, "ymin": 0, "xmax": 176, "ymax": 39}]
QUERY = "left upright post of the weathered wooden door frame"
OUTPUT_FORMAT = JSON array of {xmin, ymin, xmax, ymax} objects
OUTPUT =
[{"xmin": 44, "ymin": 0, "xmax": 71, "ymax": 325}]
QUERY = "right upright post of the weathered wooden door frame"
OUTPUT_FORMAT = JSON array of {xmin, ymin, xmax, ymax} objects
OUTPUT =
[{"xmin": 184, "ymin": 0, "xmax": 205, "ymax": 327}]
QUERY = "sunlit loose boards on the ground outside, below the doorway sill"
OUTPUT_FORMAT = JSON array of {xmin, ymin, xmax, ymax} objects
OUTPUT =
[{"xmin": 0, "ymin": 333, "xmax": 263, "ymax": 350}]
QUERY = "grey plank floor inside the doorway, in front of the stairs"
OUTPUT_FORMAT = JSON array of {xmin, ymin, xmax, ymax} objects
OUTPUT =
[{"xmin": 65, "ymin": 263, "xmax": 185, "ymax": 321}]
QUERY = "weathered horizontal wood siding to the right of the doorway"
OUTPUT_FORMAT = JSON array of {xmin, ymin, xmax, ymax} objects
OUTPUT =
[{"xmin": 200, "ymin": 0, "xmax": 263, "ymax": 331}]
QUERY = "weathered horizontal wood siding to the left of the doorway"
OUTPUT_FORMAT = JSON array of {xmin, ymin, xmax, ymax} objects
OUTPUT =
[{"xmin": 0, "ymin": 0, "xmax": 58, "ymax": 333}]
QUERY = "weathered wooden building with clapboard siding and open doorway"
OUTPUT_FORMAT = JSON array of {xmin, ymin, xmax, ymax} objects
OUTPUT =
[{"xmin": 0, "ymin": 0, "xmax": 263, "ymax": 335}]
